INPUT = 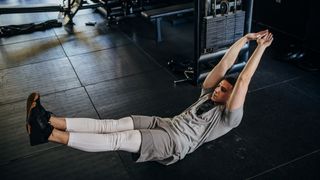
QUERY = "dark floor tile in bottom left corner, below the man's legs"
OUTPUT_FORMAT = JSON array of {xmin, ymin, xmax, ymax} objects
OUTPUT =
[{"xmin": 1, "ymin": 146, "xmax": 130, "ymax": 180}]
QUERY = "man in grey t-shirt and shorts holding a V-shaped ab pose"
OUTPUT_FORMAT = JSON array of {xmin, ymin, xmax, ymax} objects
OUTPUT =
[{"xmin": 27, "ymin": 30, "xmax": 273, "ymax": 165}]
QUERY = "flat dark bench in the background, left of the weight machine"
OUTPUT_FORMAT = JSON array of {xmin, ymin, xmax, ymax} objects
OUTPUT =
[{"xmin": 141, "ymin": 2, "xmax": 194, "ymax": 42}]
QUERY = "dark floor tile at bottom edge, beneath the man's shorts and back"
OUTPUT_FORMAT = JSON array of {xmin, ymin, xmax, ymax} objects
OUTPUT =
[{"xmin": 120, "ymin": 131, "xmax": 272, "ymax": 180}]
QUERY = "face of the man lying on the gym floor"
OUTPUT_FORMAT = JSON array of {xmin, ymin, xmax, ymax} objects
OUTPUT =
[{"xmin": 211, "ymin": 80, "xmax": 233, "ymax": 104}]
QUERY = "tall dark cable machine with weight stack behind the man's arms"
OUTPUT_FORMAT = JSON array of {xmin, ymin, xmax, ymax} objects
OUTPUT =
[{"xmin": 174, "ymin": 0, "xmax": 253, "ymax": 85}]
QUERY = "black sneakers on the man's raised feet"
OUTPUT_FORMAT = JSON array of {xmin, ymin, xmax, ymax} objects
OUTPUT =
[{"xmin": 26, "ymin": 93, "xmax": 53, "ymax": 146}]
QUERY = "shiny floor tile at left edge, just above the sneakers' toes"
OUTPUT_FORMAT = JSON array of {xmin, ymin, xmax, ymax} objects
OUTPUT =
[{"xmin": 0, "ymin": 58, "xmax": 81, "ymax": 105}]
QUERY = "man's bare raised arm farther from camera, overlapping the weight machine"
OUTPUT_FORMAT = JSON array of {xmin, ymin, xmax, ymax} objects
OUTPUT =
[{"xmin": 202, "ymin": 30, "xmax": 267, "ymax": 89}]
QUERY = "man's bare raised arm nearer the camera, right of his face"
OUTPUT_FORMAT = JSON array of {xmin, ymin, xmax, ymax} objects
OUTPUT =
[{"xmin": 226, "ymin": 33, "xmax": 273, "ymax": 110}]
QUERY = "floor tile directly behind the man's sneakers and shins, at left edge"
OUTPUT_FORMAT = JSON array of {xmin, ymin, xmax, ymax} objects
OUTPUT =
[{"xmin": 0, "ymin": 88, "xmax": 98, "ymax": 166}]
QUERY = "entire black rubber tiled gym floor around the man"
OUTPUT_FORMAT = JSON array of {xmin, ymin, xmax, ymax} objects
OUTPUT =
[{"xmin": 0, "ymin": 0, "xmax": 320, "ymax": 179}]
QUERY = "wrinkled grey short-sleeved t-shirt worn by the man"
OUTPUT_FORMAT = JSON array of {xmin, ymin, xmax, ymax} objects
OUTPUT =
[{"xmin": 159, "ymin": 89, "xmax": 243, "ymax": 164}]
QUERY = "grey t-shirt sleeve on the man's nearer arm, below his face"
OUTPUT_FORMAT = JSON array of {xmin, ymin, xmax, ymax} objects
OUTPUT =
[{"xmin": 224, "ymin": 107, "xmax": 243, "ymax": 128}]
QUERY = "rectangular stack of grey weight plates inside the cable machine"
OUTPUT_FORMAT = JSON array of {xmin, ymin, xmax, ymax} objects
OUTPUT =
[{"xmin": 201, "ymin": 10, "xmax": 245, "ymax": 52}]
